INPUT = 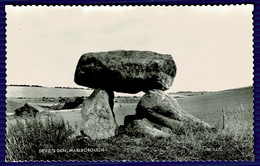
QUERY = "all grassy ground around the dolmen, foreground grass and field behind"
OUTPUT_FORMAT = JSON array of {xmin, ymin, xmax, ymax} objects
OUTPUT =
[{"xmin": 6, "ymin": 87, "xmax": 254, "ymax": 161}]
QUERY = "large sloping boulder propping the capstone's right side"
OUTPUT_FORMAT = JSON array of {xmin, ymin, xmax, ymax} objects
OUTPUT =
[{"xmin": 135, "ymin": 90, "xmax": 211, "ymax": 133}]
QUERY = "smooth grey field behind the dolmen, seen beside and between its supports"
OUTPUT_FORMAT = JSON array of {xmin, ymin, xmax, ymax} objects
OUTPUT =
[{"xmin": 7, "ymin": 87, "xmax": 253, "ymax": 125}]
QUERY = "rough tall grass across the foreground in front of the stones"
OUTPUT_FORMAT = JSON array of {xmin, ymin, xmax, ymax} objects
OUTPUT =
[{"xmin": 6, "ymin": 107, "xmax": 254, "ymax": 161}]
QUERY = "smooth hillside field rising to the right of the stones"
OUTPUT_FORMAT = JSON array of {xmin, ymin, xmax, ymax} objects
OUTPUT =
[{"xmin": 177, "ymin": 86, "xmax": 254, "ymax": 124}]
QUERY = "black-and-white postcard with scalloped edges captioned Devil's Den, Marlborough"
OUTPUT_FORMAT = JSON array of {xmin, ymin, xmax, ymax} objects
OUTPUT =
[{"xmin": 5, "ymin": 4, "xmax": 255, "ymax": 162}]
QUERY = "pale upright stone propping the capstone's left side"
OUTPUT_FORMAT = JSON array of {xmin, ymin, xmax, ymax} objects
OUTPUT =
[{"xmin": 81, "ymin": 89, "xmax": 117, "ymax": 140}]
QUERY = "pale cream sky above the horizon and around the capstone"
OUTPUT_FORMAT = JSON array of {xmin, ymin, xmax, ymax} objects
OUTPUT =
[{"xmin": 6, "ymin": 5, "xmax": 253, "ymax": 92}]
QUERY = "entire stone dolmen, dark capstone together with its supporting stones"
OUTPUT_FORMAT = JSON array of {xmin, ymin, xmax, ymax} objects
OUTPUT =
[{"xmin": 74, "ymin": 50, "xmax": 211, "ymax": 140}]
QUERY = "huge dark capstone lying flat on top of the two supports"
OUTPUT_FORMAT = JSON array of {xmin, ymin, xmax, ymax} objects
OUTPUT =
[{"xmin": 74, "ymin": 50, "xmax": 176, "ymax": 93}]
